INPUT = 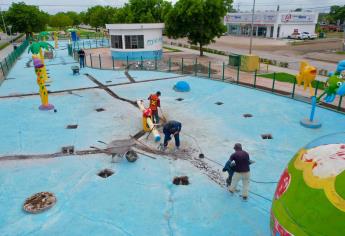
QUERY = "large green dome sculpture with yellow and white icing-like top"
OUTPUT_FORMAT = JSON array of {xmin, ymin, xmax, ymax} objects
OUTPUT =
[{"xmin": 270, "ymin": 132, "xmax": 345, "ymax": 236}]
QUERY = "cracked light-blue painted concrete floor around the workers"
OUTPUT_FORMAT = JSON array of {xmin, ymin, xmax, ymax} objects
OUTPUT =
[{"xmin": 0, "ymin": 41, "xmax": 345, "ymax": 236}]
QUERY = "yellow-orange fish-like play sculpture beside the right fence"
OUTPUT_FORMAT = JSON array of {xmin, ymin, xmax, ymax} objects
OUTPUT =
[{"xmin": 296, "ymin": 61, "xmax": 317, "ymax": 96}]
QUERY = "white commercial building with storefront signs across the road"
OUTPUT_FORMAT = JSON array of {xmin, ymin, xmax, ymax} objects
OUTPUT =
[{"xmin": 224, "ymin": 11, "xmax": 318, "ymax": 38}]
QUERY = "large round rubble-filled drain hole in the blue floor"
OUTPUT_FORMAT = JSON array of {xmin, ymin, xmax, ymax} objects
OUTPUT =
[{"xmin": 23, "ymin": 192, "xmax": 56, "ymax": 213}]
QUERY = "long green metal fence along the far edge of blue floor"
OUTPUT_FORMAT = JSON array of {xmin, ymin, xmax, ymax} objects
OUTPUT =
[{"xmin": 70, "ymin": 49, "xmax": 345, "ymax": 113}]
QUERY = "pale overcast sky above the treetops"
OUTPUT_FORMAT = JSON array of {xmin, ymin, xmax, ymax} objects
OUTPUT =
[{"xmin": 0, "ymin": 0, "xmax": 345, "ymax": 13}]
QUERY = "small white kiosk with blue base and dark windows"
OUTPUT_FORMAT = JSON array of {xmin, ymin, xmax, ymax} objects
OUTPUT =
[{"xmin": 106, "ymin": 23, "xmax": 164, "ymax": 60}]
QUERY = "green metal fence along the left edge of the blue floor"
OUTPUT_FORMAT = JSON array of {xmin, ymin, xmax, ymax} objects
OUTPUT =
[{"xmin": 0, "ymin": 40, "xmax": 29, "ymax": 84}]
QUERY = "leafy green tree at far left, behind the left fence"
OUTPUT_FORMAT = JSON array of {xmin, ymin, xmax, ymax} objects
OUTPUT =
[{"xmin": 5, "ymin": 2, "xmax": 49, "ymax": 37}]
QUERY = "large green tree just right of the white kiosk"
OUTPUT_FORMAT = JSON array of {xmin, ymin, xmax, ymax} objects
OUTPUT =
[{"xmin": 165, "ymin": 0, "xmax": 230, "ymax": 56}]
